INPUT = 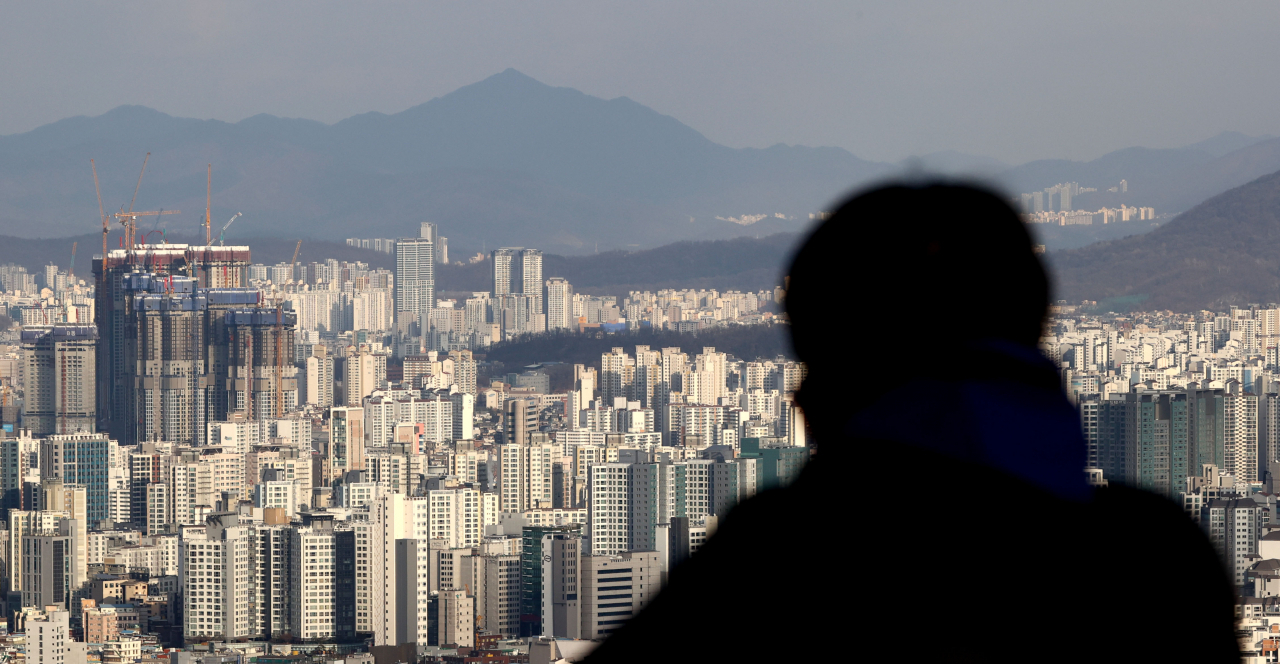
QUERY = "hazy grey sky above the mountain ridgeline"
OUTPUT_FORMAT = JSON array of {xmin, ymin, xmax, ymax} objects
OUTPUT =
[{"xmin": 0, "ymin": 0, "xmax": 1280, "ymax": 162}]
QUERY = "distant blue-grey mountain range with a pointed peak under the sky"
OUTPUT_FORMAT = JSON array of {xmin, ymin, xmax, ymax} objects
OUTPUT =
[{"xmin": 0, "ymin": 69, "xmax": 1280, "ymax": 255}]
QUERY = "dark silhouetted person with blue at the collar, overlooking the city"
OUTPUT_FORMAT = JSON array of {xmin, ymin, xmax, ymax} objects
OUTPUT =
[{"xmin": 590, "ymin": 184, "xmax": 1238, "ymax": 664}]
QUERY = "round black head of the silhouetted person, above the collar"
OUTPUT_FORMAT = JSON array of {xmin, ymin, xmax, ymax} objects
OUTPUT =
[{"xmin": 786, "ymin": 184, "xmax": 1048, "ymax": 380}]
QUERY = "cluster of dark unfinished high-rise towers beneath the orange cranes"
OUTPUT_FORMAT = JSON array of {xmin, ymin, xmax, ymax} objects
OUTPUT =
[{"xmin": 93, "ymin": 244, "xmax": 297, "ymax": 445}]
